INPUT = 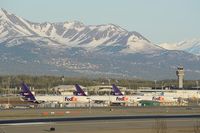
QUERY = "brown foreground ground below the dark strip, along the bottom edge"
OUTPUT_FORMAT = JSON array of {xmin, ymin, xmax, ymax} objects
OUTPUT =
[{"xmin": 0, "ymin": 118, "xmax": 198, "ymax": 133}]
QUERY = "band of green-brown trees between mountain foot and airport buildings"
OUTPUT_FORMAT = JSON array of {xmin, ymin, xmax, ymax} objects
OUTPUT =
[{"xmin": 0, "ymin": 75, "xmax": 200, "ymax": 93}]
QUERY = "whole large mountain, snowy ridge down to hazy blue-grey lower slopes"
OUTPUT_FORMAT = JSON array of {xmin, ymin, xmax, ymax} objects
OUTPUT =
[{"xmin": 0, "ymin": 9, "xmax": 200, "ymax": 80}]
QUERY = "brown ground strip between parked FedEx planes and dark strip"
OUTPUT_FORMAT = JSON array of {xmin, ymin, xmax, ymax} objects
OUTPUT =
[{"xmin": 0, "ymin": 107, "xmax": 200, "ymax": 119}]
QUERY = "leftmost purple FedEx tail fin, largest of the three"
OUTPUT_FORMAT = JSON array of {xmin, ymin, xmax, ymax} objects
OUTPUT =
[{"xmin": 20, "ymin": 83, "xmax": 36, "ymax": 102}]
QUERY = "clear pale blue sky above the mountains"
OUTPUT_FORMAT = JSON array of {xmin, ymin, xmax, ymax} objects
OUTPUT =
[{"xmin": 0, "ymin": 0, "xmax": 200, "ymax": 43}]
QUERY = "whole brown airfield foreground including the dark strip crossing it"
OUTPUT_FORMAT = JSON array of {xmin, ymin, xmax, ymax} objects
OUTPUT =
[{"xmin": 0, "ymin": 107, "xmax": 200, "ymax": 133}]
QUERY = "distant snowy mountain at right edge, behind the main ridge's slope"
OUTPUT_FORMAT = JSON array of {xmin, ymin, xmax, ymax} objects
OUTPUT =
[{"xmin": 160, "ymin": 39, "xmax": 200, "ymax": 55}]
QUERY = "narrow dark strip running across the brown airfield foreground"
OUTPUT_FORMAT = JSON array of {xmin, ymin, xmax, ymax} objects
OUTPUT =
[{"xmin": 0, "ymin": 114, "xmax": 200, "ymax": 124}]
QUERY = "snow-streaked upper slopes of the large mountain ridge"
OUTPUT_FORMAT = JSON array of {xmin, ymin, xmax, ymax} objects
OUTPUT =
[{"xmin": 0, "ymin": 9, "xmax": 162, "ymax": 53}]
